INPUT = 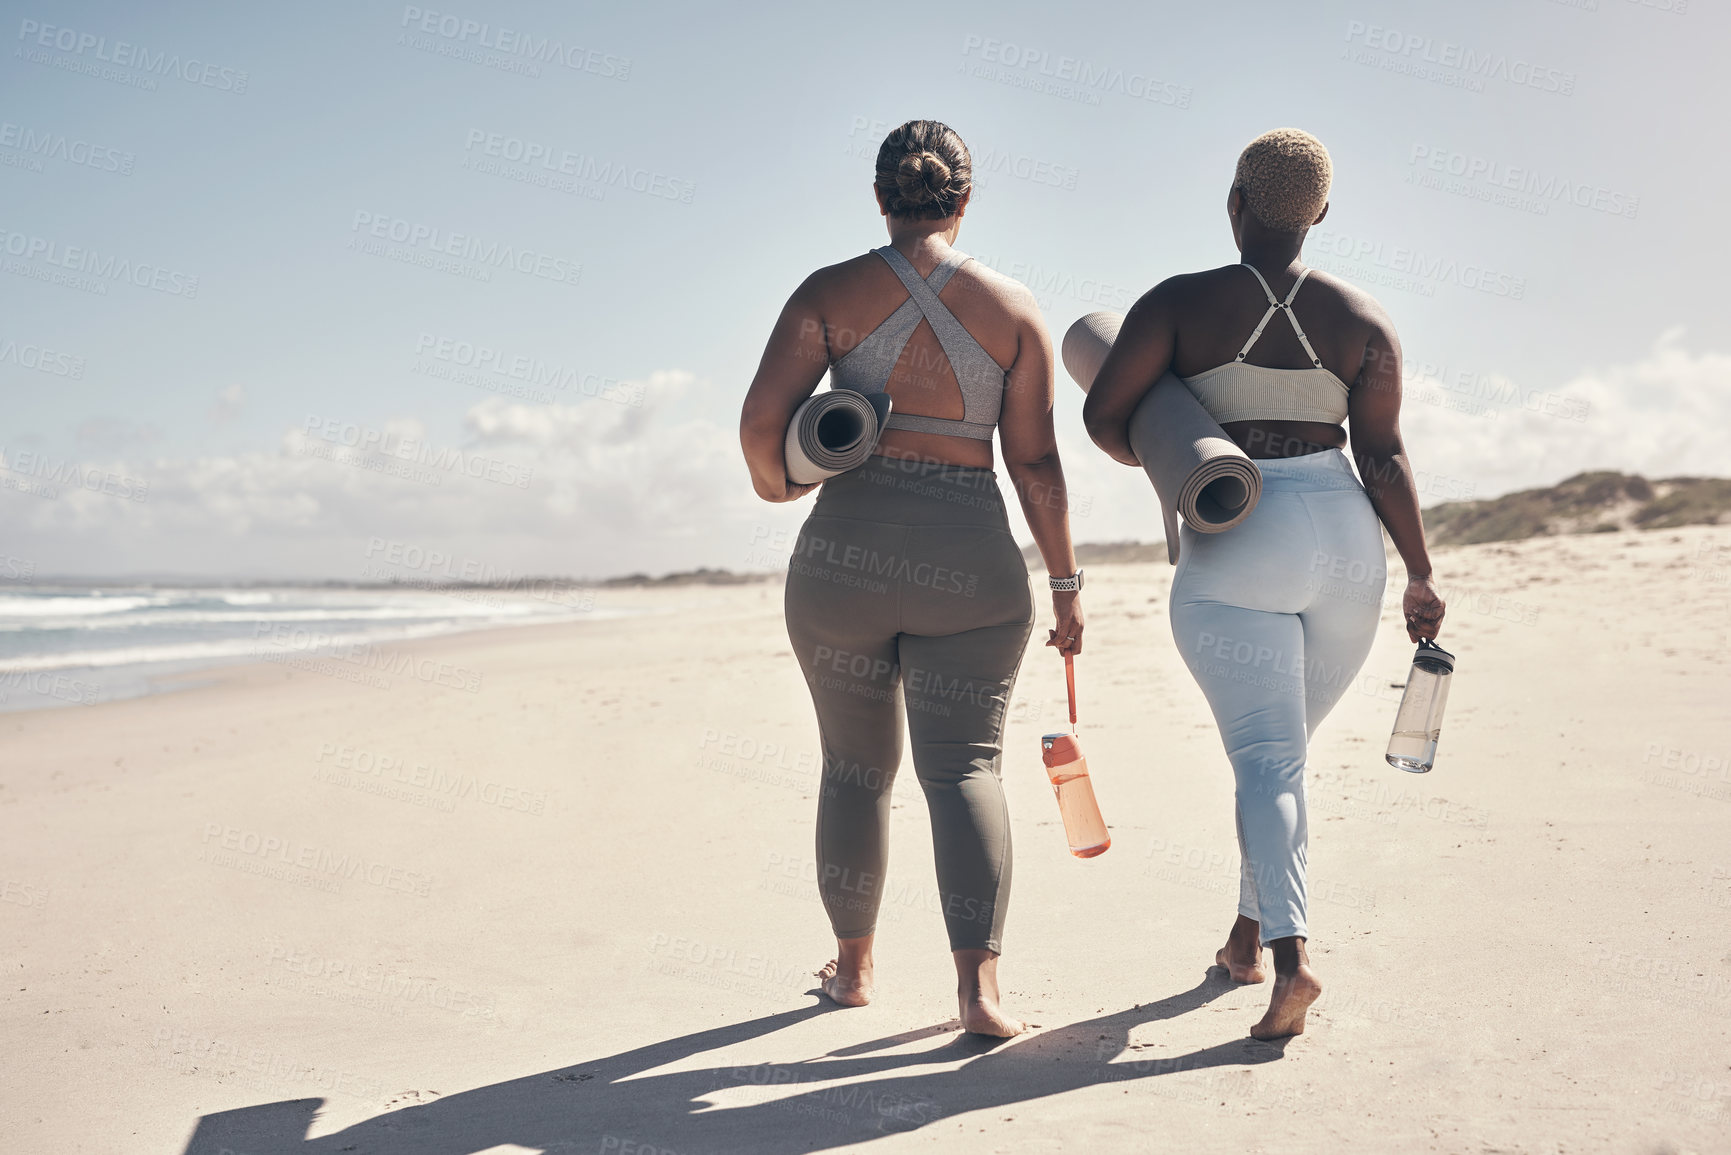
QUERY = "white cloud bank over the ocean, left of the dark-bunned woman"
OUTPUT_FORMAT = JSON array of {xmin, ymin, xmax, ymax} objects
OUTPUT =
[{"xmin": 0, "ymin": 371, "xmax": 756, "ymax": 578}]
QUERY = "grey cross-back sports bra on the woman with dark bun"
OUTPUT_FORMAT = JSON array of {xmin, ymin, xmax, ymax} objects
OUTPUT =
[{"xmin": 829, "ymin": 244, "xmax": 1006, "ymax": 442}]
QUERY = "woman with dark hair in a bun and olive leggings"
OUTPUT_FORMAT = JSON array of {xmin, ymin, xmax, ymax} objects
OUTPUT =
[{"xmin": 739, "ymin": 119, "xmax": 1082, "ymax": 1036}]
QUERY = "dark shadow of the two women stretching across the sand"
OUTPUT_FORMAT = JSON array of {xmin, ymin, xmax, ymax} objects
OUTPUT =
[{"xmin": 185, "ymin": 968, "xmax": 1284, "ymax": 1155}]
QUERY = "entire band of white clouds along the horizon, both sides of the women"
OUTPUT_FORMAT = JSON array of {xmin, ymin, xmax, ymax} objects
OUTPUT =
[{"xmin": 0, "ymin": 341, "xmax": 1731, "ymax": 578}]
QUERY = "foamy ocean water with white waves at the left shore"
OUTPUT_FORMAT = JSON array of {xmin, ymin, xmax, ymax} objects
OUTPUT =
[{"xmin": 0, "ymin": 585, "xmax": 627, "ymax": 712}]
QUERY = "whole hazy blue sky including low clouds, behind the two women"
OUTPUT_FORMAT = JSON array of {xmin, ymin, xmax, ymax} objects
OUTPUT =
[{"xmin": 0, "ymin": 0, "xmax": 1731, "ymax": 578}]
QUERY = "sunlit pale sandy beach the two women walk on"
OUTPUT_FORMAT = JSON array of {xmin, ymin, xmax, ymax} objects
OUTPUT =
[{"xmin": 0, "ymin": 526, "xmax": 1731, "ymax": 1155}]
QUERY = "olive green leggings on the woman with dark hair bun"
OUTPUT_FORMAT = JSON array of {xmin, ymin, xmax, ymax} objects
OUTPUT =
[{"xmin": 786, "ymin": 457, "xmax": 1033, "ymax": 952}]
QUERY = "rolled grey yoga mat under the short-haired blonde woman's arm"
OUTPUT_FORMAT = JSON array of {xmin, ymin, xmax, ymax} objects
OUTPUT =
[{"xmin": 1063, "ymin": 312, "xmax": 1262, "ymax": 565}]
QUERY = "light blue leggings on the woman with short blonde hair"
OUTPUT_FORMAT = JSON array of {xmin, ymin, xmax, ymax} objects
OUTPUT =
[{"xmin": 1172, "ymin": 448, "xmax": 1387, "ymax": 942}]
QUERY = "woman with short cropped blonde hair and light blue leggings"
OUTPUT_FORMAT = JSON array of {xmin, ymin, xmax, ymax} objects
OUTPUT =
[{"xmin": 1082, "ymin": 128, "xmax": 1444, "ymax": 1039}]
